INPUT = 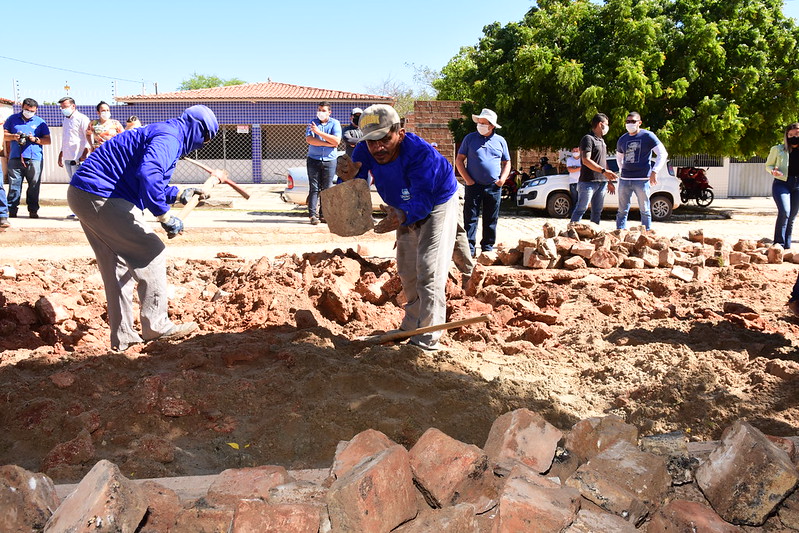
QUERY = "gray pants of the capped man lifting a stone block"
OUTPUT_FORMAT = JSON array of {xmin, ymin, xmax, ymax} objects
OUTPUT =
[{"xmin": 397, "ymin": 194, "xmax": 458, "ymax": 346}]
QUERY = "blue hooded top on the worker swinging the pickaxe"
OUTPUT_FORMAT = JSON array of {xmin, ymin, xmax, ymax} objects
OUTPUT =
[{"xmin": 70, "ymin": 105, "xmax": 219, "ymax": 216}]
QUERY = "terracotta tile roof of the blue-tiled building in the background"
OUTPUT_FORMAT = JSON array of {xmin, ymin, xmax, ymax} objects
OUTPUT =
[{"xmin": 116, "ymin": 81, "xmax": 394, "ymax": 102}]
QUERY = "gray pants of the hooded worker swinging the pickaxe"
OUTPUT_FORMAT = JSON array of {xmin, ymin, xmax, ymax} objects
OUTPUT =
[{"xmin": 67, "ymin": 186, "xmax": 174, "ymax": 348}]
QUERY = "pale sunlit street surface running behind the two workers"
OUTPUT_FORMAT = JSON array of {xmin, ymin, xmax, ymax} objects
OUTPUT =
[{"xmin": 0, "ymin": 184, "xmax": 788, "ymax": 259}]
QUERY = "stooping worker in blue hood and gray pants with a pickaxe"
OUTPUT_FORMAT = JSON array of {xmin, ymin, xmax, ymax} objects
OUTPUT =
[{"xmin": 67, "ymin": 105, "xmax": 219, "ymax": 351}]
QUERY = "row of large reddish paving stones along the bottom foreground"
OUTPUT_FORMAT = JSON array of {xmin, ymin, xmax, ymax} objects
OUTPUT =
[{"xmin": 0, "ymin": 409, "xmax": 799, "ymax": 533}]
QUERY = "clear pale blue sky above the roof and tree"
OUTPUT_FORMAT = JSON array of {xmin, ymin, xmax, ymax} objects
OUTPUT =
[{"xmin": 0, "ymin": 0, "xmax": 799, "ymax": 104}]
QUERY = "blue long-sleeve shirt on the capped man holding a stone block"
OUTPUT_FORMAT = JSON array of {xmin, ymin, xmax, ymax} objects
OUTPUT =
[{"xmin": 352, "ymin": 133, "xmax": 458, "ymax": 226}]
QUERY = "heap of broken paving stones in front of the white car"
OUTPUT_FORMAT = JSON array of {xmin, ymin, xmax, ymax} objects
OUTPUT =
[{"xmin": 477, "ymin": 222, "xmax": 799, "ymax": 281}]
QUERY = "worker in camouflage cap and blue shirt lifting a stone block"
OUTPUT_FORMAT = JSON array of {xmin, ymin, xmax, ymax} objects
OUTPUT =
[{"xmin": 336, "ymin": 104, "xmax": 459, "ymax": 350}]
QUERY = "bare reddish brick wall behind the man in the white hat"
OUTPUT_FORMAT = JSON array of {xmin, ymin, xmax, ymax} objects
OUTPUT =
[{"xmin": 405, "ymin": 100, "xmax": 571, "ymax": 173}]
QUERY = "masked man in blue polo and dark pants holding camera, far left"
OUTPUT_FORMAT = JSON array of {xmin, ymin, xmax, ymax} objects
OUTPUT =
[{"xmin": 0, "ymin": 98, "xmax": 50, "ymax": 218}]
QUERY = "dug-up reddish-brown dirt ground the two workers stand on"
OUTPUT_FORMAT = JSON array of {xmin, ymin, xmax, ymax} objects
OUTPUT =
[{"xmin": 0, "ymin": 250, "xmax": 799, "ymax": 482}]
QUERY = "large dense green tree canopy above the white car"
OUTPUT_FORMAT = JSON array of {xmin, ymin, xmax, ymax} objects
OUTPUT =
[{"xmin": 434, "ymin": 0, "xmax": 799, "ymax": 157}]
